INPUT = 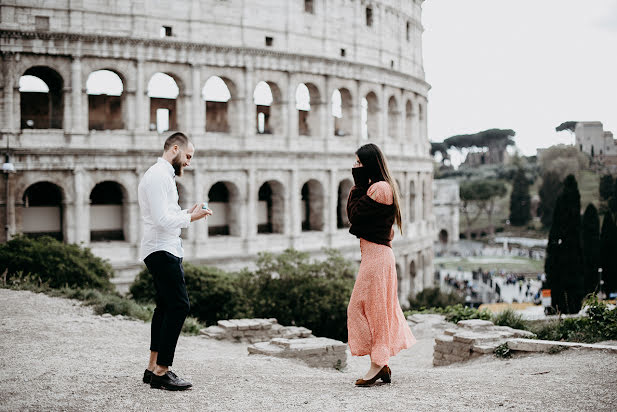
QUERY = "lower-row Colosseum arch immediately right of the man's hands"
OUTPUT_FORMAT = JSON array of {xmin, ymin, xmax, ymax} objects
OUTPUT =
[{"xmin": 207, "ymin": 181, "xmax": 241, "ymax": 236}]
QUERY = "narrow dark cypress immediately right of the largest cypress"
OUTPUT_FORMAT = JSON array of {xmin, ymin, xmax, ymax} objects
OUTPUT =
[{"xmin": 582, "ymin": 203, "xmax": 600, "ymax": 294}]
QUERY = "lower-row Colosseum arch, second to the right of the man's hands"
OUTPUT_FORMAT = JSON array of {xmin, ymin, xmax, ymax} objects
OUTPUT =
[{"xmin": 257, "ymin": 180, "xmax": 285, "ymax": 233}]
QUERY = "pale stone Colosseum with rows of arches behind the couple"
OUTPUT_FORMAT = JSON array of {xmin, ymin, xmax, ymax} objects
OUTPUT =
[{"xmin": 0, "ymin": 0, "xmax": 436, "ymax": 301}]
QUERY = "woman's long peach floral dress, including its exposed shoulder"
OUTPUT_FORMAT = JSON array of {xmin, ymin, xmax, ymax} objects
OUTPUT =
[{"xmin": 347, "ymin": 182, "xmax": 416, "ymax": 366}]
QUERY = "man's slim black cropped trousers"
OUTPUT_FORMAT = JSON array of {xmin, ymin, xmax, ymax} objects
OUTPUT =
[{"xmin": 144, "ymin": 251, "xmax": 190, "ymax": 366}]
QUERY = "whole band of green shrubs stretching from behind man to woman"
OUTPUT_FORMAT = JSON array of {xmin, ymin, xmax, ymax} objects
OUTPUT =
[{"xmin": 131, "ymin": 249, "xmax": 355, "ymax": 341}]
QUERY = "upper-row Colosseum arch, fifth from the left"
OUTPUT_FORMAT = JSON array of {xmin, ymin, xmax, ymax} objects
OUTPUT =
[{"xmin": 253, "ymin": 81, "xmax": 283, "ymax": 134}]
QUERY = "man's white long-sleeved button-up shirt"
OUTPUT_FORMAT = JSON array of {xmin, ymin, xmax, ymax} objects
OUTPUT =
[{"xmin": 138, "ymin": 157, "xmax": 191, "ymax": 260}]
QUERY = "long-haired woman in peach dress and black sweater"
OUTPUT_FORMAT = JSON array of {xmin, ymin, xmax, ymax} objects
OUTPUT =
[{"xmin": 347, "ymin": 144, "xmax": 416, "ymax": 386}]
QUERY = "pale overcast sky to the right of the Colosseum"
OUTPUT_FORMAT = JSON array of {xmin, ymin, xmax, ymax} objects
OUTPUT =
[{"xmin": 422, "ymin": 0, "xmax": 617, "ymax": 160}]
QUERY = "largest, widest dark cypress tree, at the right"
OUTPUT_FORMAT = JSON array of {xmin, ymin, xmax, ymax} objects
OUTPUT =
[{"xmin": 544, "ymin": 175, "xmax": 585, "ymax": 313}]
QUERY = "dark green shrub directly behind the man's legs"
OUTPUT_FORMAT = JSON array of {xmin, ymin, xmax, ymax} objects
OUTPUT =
[{"xmin": 130, "ymin": 263, "xmax": 250, "ymax": 325}]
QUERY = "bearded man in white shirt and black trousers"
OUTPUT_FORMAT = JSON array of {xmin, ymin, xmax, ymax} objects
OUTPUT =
[{"xmin": 138, "ymin": 133, "xmax": 212, "ymax": 390}]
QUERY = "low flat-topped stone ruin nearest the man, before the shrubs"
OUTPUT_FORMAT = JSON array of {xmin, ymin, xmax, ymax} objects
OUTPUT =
[{"xmin": 200, "ymin": 318, "xmax": 314, "ymax": 343}]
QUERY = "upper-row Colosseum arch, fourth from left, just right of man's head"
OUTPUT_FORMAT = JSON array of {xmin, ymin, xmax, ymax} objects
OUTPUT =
[{"xmin": 202, "ymin": 76, "xmax": 241, "ymax": 133}]
